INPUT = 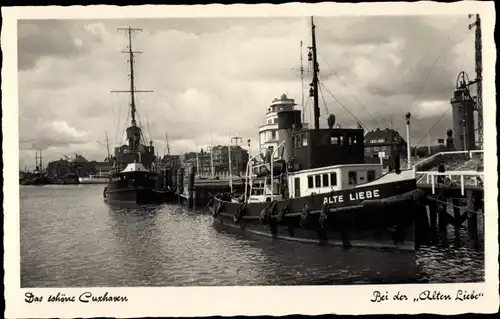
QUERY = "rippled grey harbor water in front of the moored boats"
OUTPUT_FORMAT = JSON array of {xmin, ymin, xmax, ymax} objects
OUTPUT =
[{"xmin": 20, "ymin": 185, "xmax": 484, "ymax": 288}]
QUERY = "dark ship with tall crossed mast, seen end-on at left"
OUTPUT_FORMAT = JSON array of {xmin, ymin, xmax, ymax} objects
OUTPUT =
[{"xmin": 103, "ymin": 27, "xmax": 168, "ymax": 204}]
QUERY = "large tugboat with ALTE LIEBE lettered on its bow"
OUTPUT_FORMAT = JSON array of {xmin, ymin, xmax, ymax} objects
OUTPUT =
[{"xmin": 209, "ymin": 18, "xmax": 426, "ymax": 251}]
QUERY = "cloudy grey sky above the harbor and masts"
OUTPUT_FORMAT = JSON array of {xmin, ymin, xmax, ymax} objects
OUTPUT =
[{"xmin": 18, "ymin": 16, "xmax": 474, "ymax": 167}]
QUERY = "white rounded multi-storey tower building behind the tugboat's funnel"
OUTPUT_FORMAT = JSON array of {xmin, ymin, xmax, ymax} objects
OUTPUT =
[{"xmin": 259, "ymin": 94, "xmax": 308, "ymax": 158}]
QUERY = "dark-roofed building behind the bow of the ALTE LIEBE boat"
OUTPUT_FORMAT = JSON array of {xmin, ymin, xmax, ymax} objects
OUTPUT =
[{"xmin": 364, "ymin": 128, "xmax": 406, "ymax": 163}]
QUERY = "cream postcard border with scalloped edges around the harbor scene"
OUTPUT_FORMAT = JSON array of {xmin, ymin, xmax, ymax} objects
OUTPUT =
[{"xmin": 1, "ymin": 1, "xmax": 499, "ymax": 318}]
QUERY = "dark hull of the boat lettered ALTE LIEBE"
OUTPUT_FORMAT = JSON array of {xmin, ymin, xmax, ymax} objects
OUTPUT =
[{"xmin": 210, "ymin": 180, "xmax": 425, "ymax": 251}]
